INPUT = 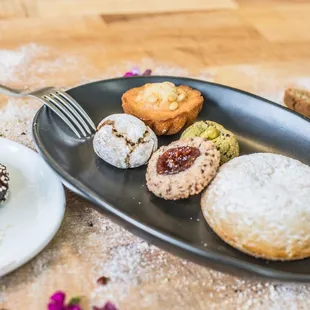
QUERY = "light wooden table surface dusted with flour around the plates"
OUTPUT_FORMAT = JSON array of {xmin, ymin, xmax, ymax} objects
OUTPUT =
[{"xmin": 0, "ymin": 0, "xmax": 310, "ymax": 310}]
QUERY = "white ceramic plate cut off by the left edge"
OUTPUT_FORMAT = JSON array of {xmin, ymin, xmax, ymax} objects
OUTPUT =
[{"xmin": 0, "ymin": 138, "xmax": 65, "ymax": 277}]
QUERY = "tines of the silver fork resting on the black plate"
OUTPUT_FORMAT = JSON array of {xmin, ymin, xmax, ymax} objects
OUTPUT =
[{"xmin": 41, "ymin": 88, "xmax": 96, "ymax": 138}]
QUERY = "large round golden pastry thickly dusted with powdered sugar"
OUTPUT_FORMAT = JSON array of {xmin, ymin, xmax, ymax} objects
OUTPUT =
[{"xmin": 201, "ymin": 153, "xmax": 310, "ymax": 260}]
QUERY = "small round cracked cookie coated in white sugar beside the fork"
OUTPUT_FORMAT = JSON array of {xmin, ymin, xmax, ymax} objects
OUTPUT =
[{"xmin": 93, "ymin": 114, "xmax": 158, "ymax": 169}]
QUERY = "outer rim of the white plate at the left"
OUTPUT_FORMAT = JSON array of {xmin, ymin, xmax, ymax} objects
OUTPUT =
[{"xmin": 0, "ymin": 137, "xmax": 66, "ymax": 278}]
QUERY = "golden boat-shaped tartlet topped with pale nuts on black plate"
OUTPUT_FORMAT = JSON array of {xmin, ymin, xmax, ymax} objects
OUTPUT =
[{"xmin": 122, "ymin": 82, "xmax": 203, "ymax": 136}]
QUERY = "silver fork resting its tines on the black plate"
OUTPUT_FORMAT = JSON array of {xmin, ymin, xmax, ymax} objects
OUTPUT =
[{"xmin": 0, "ymin": 84, "xmax": 96, "ymax": 138}]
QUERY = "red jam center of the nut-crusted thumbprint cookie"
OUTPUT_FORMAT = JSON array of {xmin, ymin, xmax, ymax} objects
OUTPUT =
[{"xmin": 157, "ymin": 146, "xmax": 200, "ymax": 175}]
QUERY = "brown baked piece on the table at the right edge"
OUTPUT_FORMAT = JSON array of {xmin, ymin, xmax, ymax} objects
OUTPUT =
[{"xmin": 284, "ymin": 88, "xmax": 310, "ymax": 118}]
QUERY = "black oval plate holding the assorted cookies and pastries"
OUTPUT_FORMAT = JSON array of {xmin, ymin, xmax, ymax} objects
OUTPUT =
[{"xmin": 33, "ymin": 76, "xmax": 310, "ymax": 282}]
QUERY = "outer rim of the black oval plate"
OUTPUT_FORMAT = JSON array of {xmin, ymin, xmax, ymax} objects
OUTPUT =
[{"xmin": 32, "ymin": 75, "xmax": 310, "ymax": 282}]
